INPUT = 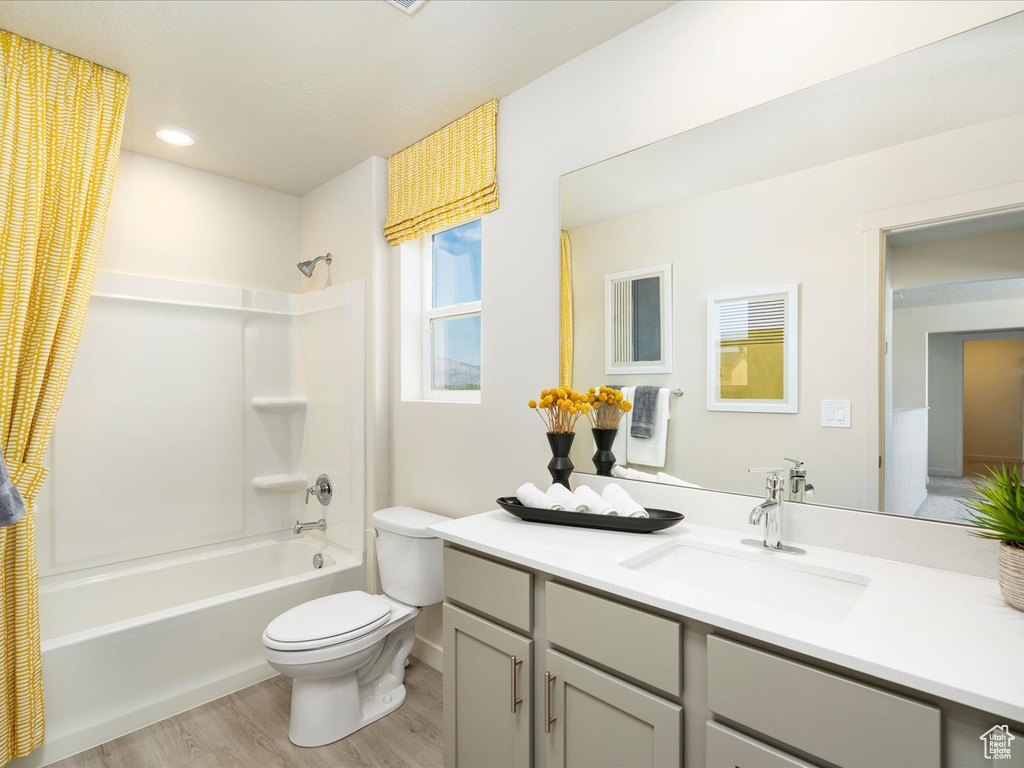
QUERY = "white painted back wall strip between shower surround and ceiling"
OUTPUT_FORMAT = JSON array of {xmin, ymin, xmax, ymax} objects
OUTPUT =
[{"xmin": 99, "ymin": 152, "xmax": 299, "ymax": 292}]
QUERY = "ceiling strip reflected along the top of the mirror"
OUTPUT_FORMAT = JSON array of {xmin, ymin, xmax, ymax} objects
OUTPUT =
[{"xmin": 561, "ymin": 13, "xmax": 1024, "ymax": 229}]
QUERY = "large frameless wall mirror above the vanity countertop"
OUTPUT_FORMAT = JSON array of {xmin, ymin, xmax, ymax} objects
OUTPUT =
[{"xmin": 561, "ymin": 14, "xmax": 1024, "ymax": 522}]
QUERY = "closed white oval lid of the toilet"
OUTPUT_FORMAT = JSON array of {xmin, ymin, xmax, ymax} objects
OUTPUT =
[{"xmin": 263, "ymin": 592, "xmax": 391, "ymax": 650}]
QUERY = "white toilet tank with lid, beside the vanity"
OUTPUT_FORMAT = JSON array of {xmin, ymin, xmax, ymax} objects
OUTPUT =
[{"xmin": 373, "ymin": 507, "xmax": 451, "ymax": 606}]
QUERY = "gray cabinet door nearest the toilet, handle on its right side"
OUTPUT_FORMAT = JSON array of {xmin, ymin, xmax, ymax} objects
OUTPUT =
[{"xmin": 444, "ymin": 604, "xmax": 534, "ymax": 768}]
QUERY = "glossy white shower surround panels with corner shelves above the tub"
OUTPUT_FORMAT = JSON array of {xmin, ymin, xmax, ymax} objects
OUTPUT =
[{"xmin": 37, "ymin": 272, "xmax": 366, "ymax": 575}]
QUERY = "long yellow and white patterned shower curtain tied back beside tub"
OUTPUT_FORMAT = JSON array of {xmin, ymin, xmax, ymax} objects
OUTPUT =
[{"xmin": 0, "ymin": 30, "xmax": 128, "ymax": 764}]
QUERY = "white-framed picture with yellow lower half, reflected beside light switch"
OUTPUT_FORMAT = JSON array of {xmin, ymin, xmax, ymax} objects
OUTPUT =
[{"xmin": 708, "ymin": 284, "xmax": 799, "ymax": 414}]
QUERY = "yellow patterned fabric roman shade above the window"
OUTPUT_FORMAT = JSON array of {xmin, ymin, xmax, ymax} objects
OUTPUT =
[{"xmin": 384, "ymin": 98, "xmax": 498, "ymax": 246}]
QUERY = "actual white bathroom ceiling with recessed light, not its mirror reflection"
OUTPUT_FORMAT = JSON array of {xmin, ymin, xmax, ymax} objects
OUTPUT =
[{"xmin": 0, "ymin": 0, "xmax": 674, "ymax": 195}]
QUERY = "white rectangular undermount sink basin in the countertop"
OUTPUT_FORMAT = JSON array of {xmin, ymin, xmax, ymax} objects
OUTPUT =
[{"xmin": 621, "ymin": 542, "xmax": 871, "ymax": 624}]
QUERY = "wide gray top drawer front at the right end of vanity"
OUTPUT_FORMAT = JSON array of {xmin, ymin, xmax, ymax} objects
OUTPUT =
[{"xmin": 708, "ymin": 635, "xmax": 941, "ymax": 768}]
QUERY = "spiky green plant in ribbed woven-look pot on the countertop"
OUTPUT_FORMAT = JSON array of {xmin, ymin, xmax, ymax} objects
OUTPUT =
[{"xmin": 968, "ymin": 465, "xmax": 1024, "ymax": 610}]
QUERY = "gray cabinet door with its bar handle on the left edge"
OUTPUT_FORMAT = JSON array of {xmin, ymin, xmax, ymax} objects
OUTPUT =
[{"xmin": 539, "ymin": 650, "xmax": 683, "ymax": 768}]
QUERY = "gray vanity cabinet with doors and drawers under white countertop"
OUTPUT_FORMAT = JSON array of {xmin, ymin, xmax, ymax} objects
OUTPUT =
[{"xmin": 443, "ymin": 544, "xmax": 1024, "ymax": 768}]
